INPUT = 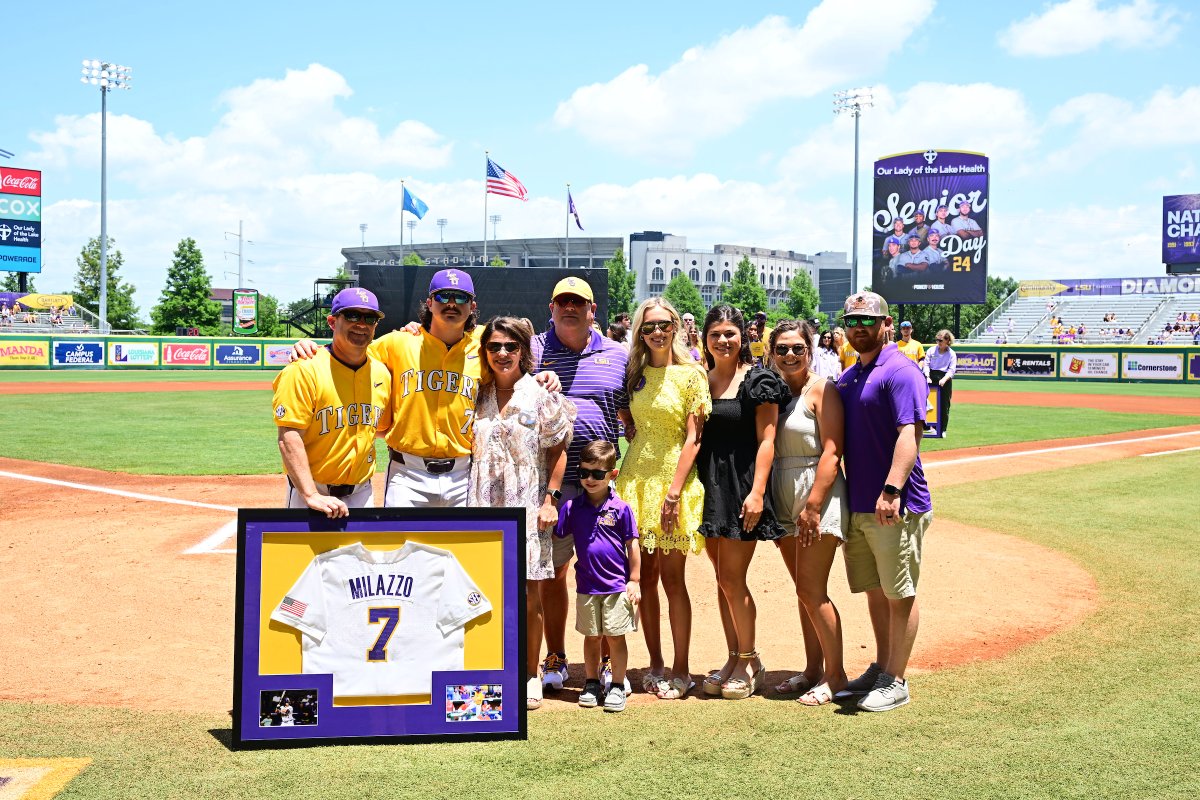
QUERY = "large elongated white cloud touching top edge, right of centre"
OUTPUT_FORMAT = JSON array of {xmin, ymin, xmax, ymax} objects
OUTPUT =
[{"xmin": 554, "ymin": 0, "xmax": 934, "ymax": 157}]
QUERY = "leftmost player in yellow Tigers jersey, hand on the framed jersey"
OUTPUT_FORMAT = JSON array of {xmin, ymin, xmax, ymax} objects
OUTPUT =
[{"xmin": 272, "ymin": 289, "xmax": 391, "ymax": 518}]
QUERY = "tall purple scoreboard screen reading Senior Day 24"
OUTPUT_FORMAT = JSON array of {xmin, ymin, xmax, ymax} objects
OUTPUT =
[{"xmin": 871, "ymin": 150, "xmax": 989, "ymax": 303}]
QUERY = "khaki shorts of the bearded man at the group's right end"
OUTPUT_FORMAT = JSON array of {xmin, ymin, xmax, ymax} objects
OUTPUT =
[{"xmin": 842, "ymin": 511, "xmax": 934, "ymax": 600}]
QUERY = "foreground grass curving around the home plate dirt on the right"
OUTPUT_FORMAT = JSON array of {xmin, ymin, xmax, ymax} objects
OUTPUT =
[{"xmin": 0, "ymin": 452, "xmax": 1200, "ymax": 800}]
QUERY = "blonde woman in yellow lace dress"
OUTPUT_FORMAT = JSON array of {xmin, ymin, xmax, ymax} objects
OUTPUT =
[{"xmin": 617, "ymin": 297, "xmax": 713, "ymax": 699}]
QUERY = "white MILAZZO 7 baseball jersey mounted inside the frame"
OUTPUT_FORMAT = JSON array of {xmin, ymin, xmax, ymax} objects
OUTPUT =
[{"xmin": 271, "ymin": 542, "xmax": 492, "ymax": 697}]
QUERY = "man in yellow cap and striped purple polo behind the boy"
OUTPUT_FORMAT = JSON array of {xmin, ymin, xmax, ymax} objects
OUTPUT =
[{"xmin": 533, "ymin": 278, "xmax": 634, "ymax": 690}]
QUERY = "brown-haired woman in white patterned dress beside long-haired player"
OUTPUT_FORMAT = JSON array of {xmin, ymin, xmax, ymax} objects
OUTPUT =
[{"xmin": 467, "ymin": 317, "xmax": 575, "ymax": 708}]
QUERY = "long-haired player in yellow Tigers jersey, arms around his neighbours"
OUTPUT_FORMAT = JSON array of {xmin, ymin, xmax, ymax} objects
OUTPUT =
[{"xmin": 295, "ymin": 270, "xmax": 480, "ymax": 509}]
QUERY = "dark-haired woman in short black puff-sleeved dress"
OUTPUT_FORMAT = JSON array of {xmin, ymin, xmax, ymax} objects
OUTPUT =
[{"xmin": 696, "ymin": 305, "xmax": 791, "ymax": 699}]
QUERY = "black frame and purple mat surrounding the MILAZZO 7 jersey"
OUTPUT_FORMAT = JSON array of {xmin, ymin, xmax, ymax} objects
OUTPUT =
[{"xmin": 230, "ymin": 509, "xmax": 528, "ymax": 750}]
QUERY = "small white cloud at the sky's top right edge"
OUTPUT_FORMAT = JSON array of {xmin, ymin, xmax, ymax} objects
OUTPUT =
[{"xmin": 997, "ymin": 0, "xmax": 1180, "ymax": 58}]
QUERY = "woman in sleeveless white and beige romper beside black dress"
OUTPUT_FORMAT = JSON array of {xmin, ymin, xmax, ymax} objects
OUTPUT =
[{"xmin": 770, "ymin": 320, "xmax": 850, "ymax": 705}]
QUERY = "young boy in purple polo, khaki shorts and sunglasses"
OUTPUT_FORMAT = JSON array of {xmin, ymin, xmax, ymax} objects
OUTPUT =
[{"xmin": 554, "ymin": 439, "xmax": 642, "ymax": 711}]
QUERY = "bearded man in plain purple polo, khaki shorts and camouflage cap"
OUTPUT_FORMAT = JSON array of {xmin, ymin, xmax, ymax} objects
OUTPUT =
[{"xmin": 838, "ymin": 291, "xmax": 934, "ymax": 711}]
